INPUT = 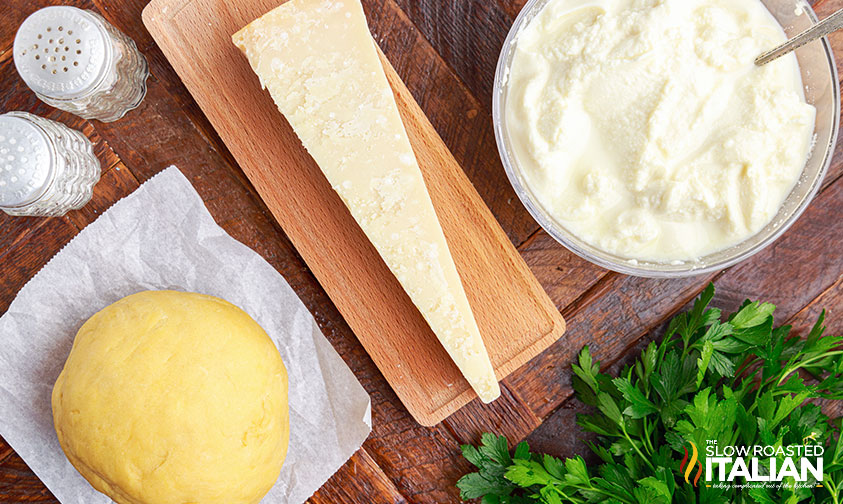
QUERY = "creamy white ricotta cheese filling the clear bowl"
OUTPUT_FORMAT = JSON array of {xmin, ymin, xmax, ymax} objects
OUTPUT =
[{"xmin": 503, "ymin": 0, "xmax": 815, "ymax": 263}]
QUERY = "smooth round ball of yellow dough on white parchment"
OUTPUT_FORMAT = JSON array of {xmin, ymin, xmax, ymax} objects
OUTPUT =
[{"xmin": 52, "ymin": 291, "xmax": 290, "ymax": 504}]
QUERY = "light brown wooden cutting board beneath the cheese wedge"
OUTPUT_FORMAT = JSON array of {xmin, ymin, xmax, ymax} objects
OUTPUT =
[{"xmin": 143, "ymin": 0, "xmax": 565, "ymax": 425}]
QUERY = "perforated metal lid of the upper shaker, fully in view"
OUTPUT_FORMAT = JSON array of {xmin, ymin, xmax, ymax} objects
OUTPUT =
[{"xmin": 14, "ymin": 6, "xmax": 112, "ymax": 100}]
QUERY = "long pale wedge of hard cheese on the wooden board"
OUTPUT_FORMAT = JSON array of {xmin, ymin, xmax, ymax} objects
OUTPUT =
[{"xmin": 233, "ymin": 0, "xmax": 500, "ymax": 402}]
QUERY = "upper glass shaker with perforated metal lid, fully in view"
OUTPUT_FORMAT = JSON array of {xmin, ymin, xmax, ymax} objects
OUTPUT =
[{"xmin": 13, "ymin": 6, "xmax": 149, "ymax": 122}]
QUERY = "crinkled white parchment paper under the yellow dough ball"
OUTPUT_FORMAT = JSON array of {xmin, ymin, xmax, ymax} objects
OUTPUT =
[{"xmin": 0, "ymin": 167, "xmax": 371, "ymax": 504}]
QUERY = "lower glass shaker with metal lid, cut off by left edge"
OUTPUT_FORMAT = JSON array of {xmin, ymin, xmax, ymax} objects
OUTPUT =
[{"xmin": 0, "ymin": 112, "xmax": 100, "ymax": 217}]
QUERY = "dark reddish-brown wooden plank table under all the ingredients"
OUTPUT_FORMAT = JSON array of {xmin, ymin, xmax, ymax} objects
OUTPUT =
[{"xmin": 0, "ymin": 0, "xmax": 843, "ymax": 504}]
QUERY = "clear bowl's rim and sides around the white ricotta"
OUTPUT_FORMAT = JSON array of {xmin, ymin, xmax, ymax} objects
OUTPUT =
[{"xmin": 492, "ymin": 0, "xmax": 840, "ymax": 278}]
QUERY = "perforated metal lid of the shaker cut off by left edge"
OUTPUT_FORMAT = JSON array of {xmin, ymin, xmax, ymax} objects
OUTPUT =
[{"xmin": 0, "ymin": 112, "xmax": 54, "ymax": 208}]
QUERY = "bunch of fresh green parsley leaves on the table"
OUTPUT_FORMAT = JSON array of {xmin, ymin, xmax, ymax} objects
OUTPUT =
[{"xmin": 457, "ymin": 285, "xmax": 843, "ymax": 504}]
